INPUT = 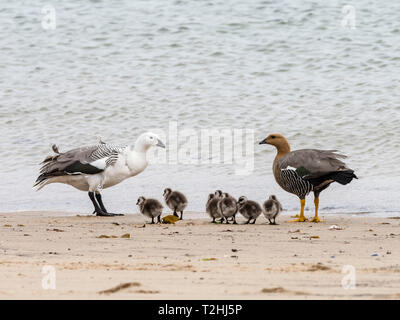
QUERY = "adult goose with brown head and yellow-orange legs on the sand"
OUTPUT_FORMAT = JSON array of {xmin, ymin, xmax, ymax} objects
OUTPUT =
[{"xmin": 260, "ymin": 133, "xmax": 358, "ymax": 222}]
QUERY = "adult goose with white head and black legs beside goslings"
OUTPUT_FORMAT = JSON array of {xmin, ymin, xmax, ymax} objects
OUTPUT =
[{"xmin": 34, "ymin": 132, "xmax": 165, "ymax": 216}]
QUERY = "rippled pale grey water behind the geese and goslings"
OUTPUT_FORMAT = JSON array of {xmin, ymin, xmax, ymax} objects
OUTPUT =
[{"xmin": 0, "ymin": 0, "xmax": 400, "ymax": 216}]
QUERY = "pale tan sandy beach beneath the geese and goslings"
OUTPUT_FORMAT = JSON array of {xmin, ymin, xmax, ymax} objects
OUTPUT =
[{"xmin": 0, "ymin": 212, "xmax": 400, "ymax": 299}]
